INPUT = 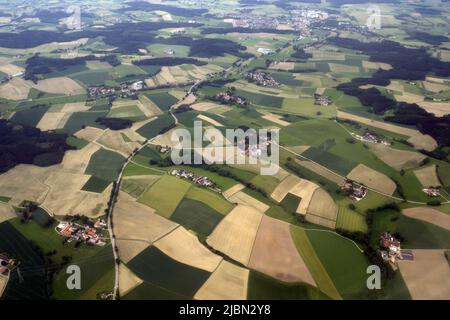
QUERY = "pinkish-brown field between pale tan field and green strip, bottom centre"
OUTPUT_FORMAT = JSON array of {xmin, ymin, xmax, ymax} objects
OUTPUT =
[{"xmin": 248, "ymin": 216, "xmax": 316, "ymax": 286}]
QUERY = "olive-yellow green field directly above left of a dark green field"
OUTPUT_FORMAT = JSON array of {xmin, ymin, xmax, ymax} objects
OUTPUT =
[{"xmin": 138, "ymin": 175, "xmax": 191, "ymax": 218}]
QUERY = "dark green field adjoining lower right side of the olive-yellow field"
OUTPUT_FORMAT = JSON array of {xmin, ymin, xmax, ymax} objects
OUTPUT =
[{"xmin": 170, "ymin": 199, "xmax": 223, "ymax": 237}]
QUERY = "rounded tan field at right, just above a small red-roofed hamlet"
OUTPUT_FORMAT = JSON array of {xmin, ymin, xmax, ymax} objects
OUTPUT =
[{"xmin": 347, "ymin": 164, "xmax": 397, "ymax": 195}]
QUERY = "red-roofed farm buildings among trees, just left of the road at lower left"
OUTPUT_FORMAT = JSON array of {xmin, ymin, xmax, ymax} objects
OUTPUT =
[{"xmin": 55, "ymin": 219, "xmax": 107, "ymax": 246}]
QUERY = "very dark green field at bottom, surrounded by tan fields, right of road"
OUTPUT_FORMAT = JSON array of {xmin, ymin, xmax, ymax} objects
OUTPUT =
[{"xmin": 128, "ymin": 246, "xmax": 210, "ymax": 297}]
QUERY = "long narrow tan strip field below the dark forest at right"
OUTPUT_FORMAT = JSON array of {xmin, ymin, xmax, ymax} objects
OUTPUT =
[{"xmin": 337, "ymin": 111, "xmax": 437, "ymax": 151}]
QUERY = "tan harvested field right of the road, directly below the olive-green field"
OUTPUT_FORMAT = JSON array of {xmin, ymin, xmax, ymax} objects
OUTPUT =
[{"xmin": 113, "ymin": 192, "xmax": 178, "ymax": 251}]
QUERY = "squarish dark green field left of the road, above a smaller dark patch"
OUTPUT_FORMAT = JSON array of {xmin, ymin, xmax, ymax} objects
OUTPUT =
[{"xmin": 85, "ymin": 149, "xmax": 125, "ymax": 182}]
